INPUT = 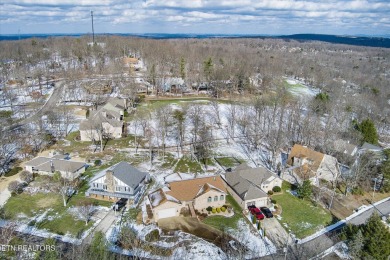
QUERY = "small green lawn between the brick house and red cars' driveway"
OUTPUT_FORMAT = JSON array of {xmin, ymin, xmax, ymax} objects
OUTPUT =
[{"xmin": 203, "ymin": 195, "xmax": 243, "ymax": 231}]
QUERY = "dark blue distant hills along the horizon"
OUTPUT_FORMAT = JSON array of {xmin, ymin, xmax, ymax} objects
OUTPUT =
[{"xmin": 0, "ymin": 33, "xmax": 390, "ymax": 48}]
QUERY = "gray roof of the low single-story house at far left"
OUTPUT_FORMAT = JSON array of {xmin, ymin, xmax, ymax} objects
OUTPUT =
[{"xmin": 25, "ymin": 157, "xmax": 85, "ymax": 173}]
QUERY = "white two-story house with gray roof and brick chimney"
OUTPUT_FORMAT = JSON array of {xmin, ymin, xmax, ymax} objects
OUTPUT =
[{"xmin": 86, "ymin": 162, "xmax": 149, "ymax": 200}]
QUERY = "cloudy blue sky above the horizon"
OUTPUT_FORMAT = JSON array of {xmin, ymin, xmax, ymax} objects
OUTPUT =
[{"xmin": 0, "ymin": 0, "xmax": 390, "ymax": 35}]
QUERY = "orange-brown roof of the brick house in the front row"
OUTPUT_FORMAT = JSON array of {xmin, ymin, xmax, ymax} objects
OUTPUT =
[{"xmin": 166, "ymin": 176, "xmax": 227, "ymax": 201}]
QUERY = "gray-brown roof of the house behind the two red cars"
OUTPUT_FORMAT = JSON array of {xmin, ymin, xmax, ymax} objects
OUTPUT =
[{"xmin": 225, "ymin": 164, "xmax": 277, "ymax": 200}]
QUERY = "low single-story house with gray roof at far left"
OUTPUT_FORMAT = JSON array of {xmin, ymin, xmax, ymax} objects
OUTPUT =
[{"xmin": 24, "ymin": 155, "xmax": 86, "ymax": 180}]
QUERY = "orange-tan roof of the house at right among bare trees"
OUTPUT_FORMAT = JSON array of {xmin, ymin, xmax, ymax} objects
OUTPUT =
[{"xmin": 287, "ymin": 144, "xmax": 325, "ymax": 171}]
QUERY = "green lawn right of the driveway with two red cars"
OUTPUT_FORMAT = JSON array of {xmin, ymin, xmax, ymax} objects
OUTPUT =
[{"xmin": 272, "ymin": 182, "xmax": 332, "ymax": 238}]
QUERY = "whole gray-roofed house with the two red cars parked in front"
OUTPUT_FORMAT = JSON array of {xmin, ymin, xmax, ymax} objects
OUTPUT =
[{"xmin": 225, "ymin": 164, "xmax": 282, "ymax": 209}]
